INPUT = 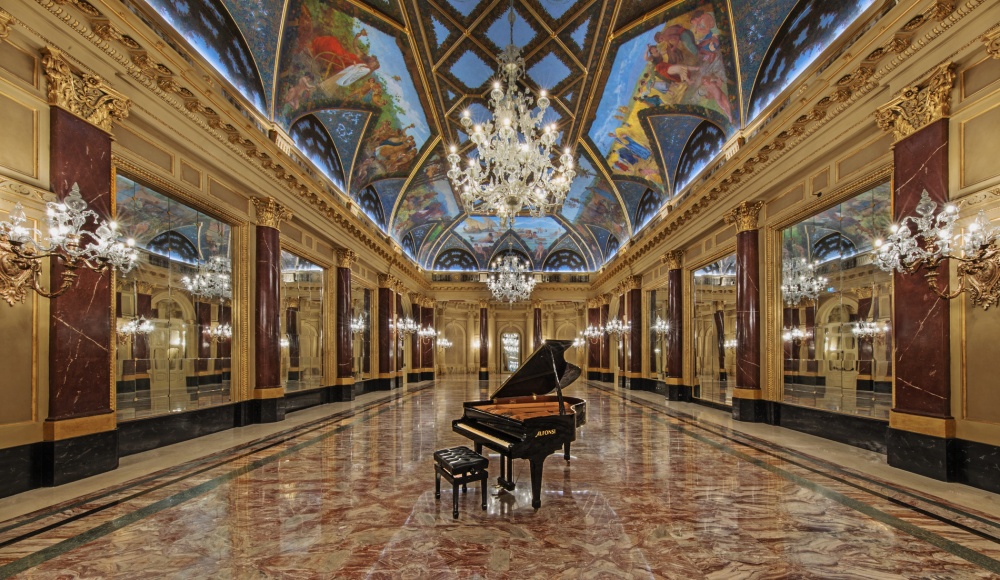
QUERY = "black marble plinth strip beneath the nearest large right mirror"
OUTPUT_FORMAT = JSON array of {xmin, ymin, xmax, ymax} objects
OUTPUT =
[{"xmin": 764, "ymin": 401, "xmax": 889, "ymax": 453}]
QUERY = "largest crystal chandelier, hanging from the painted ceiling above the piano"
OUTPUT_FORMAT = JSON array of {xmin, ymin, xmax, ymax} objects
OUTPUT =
[{"xmin": 448, "ymin": 0, "xmax": 576, "ymax": 227}]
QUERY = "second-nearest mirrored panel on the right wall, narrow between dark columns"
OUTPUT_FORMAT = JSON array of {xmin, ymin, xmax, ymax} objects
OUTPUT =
[{"xmin": 694, "ymin": 253, "xmax": 736, "ymax": 405}]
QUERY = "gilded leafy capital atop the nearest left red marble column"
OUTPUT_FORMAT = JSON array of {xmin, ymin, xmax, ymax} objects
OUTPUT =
[{"xmin": 40, "ymin": 46, "xmax": 131, "ymax": 133}]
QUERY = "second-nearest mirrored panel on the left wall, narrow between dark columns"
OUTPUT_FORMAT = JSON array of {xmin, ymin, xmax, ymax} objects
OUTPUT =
[{"xmin": 280, "ymin": 250, "xmax": 324, "ymax": 392}]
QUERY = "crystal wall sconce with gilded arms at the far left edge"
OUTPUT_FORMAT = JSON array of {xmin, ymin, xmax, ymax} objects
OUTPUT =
[{"xmin": 0, "ymin": 183, "xmax": 139, "ymax": 306}]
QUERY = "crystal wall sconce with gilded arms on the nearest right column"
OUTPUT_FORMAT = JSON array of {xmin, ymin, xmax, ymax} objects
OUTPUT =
[{"xmin": 875, "ymin": 190, "xmax": 1000, "ymax": 310}]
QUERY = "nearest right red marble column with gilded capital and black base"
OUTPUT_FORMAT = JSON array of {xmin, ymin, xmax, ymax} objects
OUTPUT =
[{"xmin": 876, "ymin": 63, "xmax": 964, "ymax": 481}]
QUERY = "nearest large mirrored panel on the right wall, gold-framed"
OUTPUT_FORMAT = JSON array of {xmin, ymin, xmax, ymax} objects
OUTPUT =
[{"xmin": 780, "ymin": 183, "xmax": 893, "ymax": 419}]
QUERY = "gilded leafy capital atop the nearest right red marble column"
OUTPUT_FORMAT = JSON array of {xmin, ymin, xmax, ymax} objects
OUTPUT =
[{"xmin": 875, "ymin": 62, "xmax": 955, "ymax": 141}]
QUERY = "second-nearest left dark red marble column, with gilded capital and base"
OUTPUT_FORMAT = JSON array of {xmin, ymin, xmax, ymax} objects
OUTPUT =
[{"xmin": 250, "ymin": 197, "xmax": 292, "ymax": 423}]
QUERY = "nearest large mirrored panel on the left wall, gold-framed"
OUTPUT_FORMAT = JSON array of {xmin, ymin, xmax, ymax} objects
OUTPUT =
[{"xmin": 115, "ymin": 175, "xmax": 233, "ymax": 420}]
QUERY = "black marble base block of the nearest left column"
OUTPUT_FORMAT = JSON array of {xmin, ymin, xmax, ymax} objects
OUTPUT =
[{"xmin": 36, "ymin": 430, "xmax": 118, "ymax": 487}]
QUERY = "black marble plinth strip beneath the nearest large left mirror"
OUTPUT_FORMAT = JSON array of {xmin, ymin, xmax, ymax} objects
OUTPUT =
[{"xmin": 118, "ymin": 405, "xmax": 236, "ymax": 457}]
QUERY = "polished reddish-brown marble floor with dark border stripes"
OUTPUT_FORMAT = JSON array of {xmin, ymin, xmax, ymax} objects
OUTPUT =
[{"xmin": 0, "ymin": 378, "xmax": 1000, "ymax": 579}]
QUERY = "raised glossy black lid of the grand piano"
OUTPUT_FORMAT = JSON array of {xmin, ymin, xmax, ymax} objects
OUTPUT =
[{"xmin": 490, "ymin": 340, "xmax": 581, "ymax": 400}]
